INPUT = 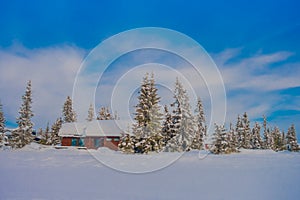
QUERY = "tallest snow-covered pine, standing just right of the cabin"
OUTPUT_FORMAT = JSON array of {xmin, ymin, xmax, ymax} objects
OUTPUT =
[{"xmin": 132, "ymin": 73, "xmax": 163, "ymax": 153}]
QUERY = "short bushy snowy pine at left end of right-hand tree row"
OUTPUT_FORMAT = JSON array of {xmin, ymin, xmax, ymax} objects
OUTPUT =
[{"xmin": 211, "ymin": 124, "xmax": 232, "ymax": 154}]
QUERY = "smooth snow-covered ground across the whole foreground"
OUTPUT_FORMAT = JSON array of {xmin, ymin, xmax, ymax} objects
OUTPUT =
[{"xmin": 0, "ymin": 146, "xmax": 300, "ymax": 200}]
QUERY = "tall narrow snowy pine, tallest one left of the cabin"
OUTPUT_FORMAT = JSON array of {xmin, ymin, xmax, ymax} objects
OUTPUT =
[{"xmin": 10, "ymin": 81, "xmax": 34, "ymax": 148}]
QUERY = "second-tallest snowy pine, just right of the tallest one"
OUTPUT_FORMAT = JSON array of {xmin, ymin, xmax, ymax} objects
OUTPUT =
[{"xmin": 165, "ymin": 78, "xmax": 196, "ymax": 152}]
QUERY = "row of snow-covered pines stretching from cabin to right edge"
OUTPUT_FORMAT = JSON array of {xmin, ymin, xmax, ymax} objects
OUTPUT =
[{"xmin": 119, "ymin": 73, "xmax": 299, "ymax": 154}]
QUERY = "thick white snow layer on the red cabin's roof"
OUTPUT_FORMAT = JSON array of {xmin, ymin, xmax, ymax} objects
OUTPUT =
[{"xmin": 58, "ymin": 120, "xmax": 128, "ymax": 137}]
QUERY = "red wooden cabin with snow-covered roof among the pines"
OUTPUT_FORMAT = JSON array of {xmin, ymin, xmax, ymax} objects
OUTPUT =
[{"xmin": 58, "ymin": 120, "xmax": 124, "ymax": 150}]
